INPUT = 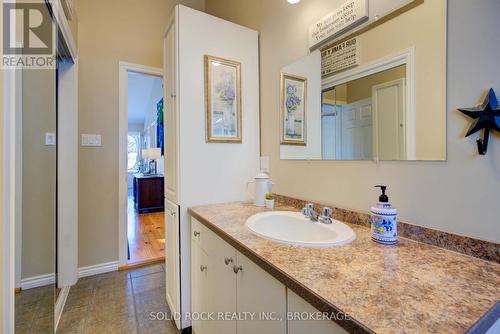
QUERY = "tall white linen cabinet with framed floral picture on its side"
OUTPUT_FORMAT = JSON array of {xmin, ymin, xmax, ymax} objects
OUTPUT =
[{"xmin": 164, "ymin": 5, "xmax": 260, "ymax": 329}]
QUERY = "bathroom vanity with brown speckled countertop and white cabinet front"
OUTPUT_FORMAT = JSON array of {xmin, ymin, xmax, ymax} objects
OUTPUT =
[{"xmin": 189, "ymin": 203, "xmax": 500, "ymax": 334}]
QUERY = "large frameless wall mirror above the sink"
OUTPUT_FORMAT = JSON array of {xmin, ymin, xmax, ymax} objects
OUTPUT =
[{"xmin": 280, "ymin": 0, "xmax": 446, "ymax": 160}]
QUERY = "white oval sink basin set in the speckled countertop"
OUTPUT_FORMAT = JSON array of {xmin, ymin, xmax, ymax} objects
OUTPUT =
[{"xmin": 245, "ymin": 211, "xmax": 356, "ymax": 247}]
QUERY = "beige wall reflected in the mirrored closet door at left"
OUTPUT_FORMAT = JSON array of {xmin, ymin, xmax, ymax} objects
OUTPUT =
[{"xmin": 21, "ymin": 70, "xmax": 56, "ymax": 278}]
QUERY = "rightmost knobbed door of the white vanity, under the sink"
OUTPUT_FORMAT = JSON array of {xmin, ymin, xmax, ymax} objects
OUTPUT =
[{"xmin": 236, "ymin": 252, "xmax": 286, "ymax": 334}]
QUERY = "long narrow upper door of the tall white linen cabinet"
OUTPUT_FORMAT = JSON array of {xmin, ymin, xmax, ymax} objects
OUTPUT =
[{"xmin": 163, "ymin": 20, "xmax": 179, "ymax": 203}]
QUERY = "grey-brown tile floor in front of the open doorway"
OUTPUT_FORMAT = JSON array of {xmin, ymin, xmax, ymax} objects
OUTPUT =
[{"xmin": 57, "ymin": 264, "xmax": 178, "ymax": 334}]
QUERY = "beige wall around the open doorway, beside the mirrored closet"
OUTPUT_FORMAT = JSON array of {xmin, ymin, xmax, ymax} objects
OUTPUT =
[{"xmin": 76, "ymin": 0, "xmax": 169, "ymax": 267}]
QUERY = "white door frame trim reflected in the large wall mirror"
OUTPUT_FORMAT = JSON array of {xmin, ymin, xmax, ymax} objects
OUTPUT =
[{"xmin": 321, "ymin": 47, "xmax": 416, "ymax": 160}]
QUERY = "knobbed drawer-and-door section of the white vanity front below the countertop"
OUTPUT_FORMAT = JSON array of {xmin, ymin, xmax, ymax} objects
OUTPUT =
[{"xmin": 191, "ymin": 218, "xmax": 286, "ymax": 334}]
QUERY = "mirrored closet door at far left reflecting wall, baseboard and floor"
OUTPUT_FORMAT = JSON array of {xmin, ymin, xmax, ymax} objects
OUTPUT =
[{"xmin": 14, "ymin": 69, "xmax": 56, "ymax": 334}]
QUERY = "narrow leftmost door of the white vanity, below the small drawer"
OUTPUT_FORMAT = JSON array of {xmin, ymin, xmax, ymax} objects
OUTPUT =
[{"xmin": 191, "ymin": 243, "xmax": 208, "ymax": 334}]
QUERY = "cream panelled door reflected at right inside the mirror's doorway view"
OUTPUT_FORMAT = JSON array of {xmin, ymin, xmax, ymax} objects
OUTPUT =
[{"xmin": 372, "ymin": 79, "xmax": 406, "ymax": 160}]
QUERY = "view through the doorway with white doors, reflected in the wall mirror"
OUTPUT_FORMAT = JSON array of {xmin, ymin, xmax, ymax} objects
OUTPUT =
[{"xmin": 321, "ymin": 65, "xmax": 411, "ymax": 160}]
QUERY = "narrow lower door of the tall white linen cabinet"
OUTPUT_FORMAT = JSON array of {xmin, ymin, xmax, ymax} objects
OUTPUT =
[{"xmin": 165, "ymin": 201, "xmax": 181, "ymax": 328}]
